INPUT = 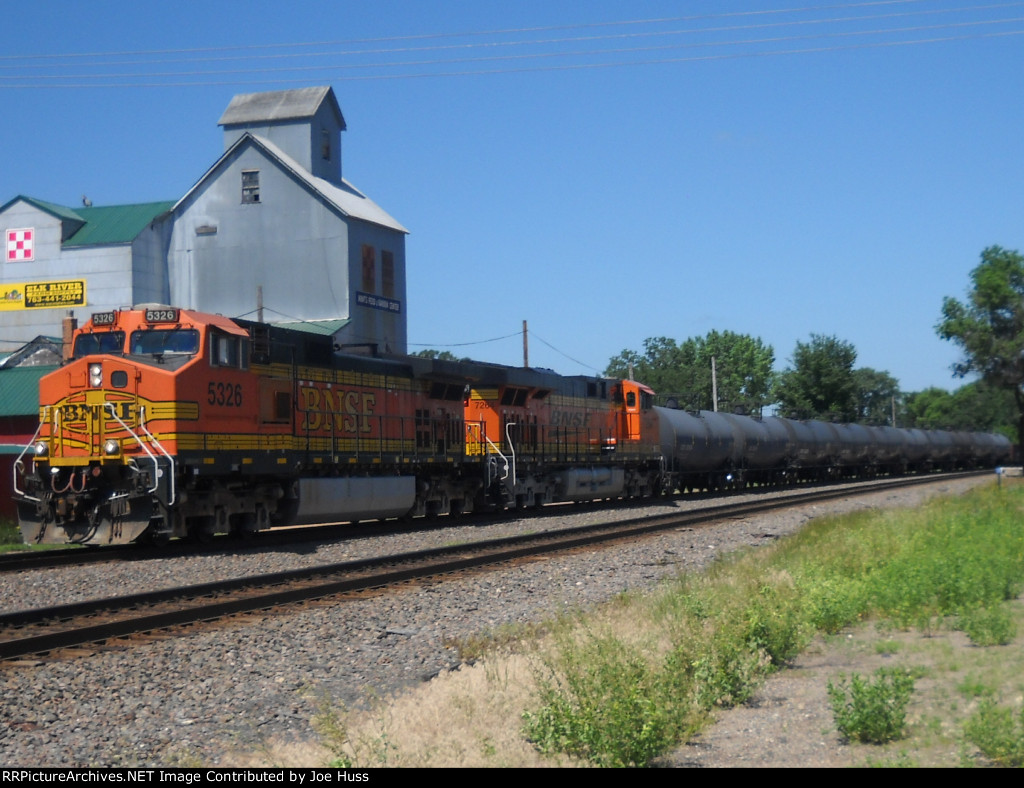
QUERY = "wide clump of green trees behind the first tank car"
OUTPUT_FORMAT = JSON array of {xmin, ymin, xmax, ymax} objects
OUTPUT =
[{"xmin": 604, "ymin": 331, "xmax": 775, "ymax": 412}]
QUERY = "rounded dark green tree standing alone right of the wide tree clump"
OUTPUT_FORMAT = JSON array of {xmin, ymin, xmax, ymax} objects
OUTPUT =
[{"xmin": 775, "ymin": 334, "xmax": 858, "ymax": 422}]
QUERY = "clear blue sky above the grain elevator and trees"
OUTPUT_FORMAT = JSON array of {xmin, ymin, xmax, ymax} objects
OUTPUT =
[{"xmin": 0, "ymin": 0, "xmax": 1024, "ymax": 391}]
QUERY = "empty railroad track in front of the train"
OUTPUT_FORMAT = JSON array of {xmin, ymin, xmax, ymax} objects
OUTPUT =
[{"xmin": 0, "ymin": 474, "xmax": 991, "ymax": 665}]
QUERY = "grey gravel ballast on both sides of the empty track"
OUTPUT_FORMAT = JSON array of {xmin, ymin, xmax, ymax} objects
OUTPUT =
[{"xmin": 0, "ymin": 477, "xmax": 990, "ymax": 767}]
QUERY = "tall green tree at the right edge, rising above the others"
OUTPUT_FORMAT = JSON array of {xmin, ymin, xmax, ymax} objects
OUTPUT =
[{"xmin": 935, "ymin": 247, "xmax": 1024, "ymax": 449}]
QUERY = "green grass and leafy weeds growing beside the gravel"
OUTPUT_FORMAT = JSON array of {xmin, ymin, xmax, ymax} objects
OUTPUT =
[{"xmin": 524, "ymin": 487, "xmax": 1024, "ymax": 767}]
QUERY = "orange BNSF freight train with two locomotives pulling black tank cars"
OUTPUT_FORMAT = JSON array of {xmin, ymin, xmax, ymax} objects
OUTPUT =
[{"xmin": 14, "ymin": 305, "xmax": 1011, "ymax": 544}]
